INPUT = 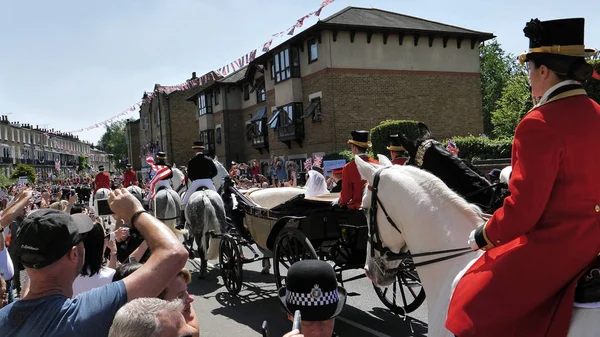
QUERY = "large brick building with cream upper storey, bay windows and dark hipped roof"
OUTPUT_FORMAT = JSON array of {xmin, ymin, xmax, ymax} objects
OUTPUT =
[{"xmin": 189, "ymin": 7, "xmax": 494, "ymax": 171}]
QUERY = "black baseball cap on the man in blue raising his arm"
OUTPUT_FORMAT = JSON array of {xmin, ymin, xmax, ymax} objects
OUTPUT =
[{"xmin": 16, "ymin": 209, "xmax": 94, "ymax": 269}]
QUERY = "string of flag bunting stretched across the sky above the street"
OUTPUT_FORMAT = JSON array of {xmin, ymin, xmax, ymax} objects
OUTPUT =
[{"xmin": 63, "ymin": 0, "xmax": 335, "ymax": 133}]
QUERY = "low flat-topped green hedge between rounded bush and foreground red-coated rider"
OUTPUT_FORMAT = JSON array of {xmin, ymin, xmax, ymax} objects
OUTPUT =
[{"xmin": 443, "ymin": 136, "xmax": 513, "ymax": 161}]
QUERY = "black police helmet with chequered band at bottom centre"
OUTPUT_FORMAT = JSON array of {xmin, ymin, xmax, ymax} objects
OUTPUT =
[{"xmin": 279, "ymin": 260, "xmax": 346, "ymax": 321}]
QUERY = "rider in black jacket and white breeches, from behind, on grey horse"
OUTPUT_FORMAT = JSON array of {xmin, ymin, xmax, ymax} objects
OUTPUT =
[{"xmin": 182, "ymin": 141, "xmax": 217, "ymax": 205}]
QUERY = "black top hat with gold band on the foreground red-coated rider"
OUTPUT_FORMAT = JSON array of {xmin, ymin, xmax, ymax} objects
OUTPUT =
[{"xmin": 518, "ymin": 18, "xmax": 598, "ymax": 65}]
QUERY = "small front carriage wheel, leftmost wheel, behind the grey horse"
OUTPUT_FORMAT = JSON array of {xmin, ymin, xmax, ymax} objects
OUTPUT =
[{"xmin": 219, "ymin": 234, "xmax": 243, "ymax": 295}]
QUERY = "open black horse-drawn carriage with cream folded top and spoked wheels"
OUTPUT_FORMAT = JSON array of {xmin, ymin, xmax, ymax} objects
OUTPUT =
[{"xmin": 219, "ymin": 182, "xmax": 425, "ymax": 314}]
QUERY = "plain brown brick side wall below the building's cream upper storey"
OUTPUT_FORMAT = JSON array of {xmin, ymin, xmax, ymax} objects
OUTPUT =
[{"xmin": 326, "ymin": 69, "xmax": 483, "ymax": 151}]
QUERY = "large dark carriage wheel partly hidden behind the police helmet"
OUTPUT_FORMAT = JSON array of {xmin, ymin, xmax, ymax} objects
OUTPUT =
[{"xmin": 273, "ymin": 227, "xmax": 318, "ymax": 289}]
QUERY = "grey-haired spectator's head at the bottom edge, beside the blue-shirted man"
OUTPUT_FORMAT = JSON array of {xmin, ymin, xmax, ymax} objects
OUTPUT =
[{"xmin": 108, "ymin": 298, "xmax": 193, "ymax": 337}]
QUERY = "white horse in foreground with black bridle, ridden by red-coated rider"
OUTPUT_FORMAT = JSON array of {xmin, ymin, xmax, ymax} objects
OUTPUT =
[{"xmin": 356, "ymin": 155, "xmax": 600, "ymax": 337}]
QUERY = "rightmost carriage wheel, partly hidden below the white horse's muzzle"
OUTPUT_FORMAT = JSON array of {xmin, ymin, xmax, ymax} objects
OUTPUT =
[{"xmin": 373, "ymin": 269, "xmax": 425, "ymax": 315}]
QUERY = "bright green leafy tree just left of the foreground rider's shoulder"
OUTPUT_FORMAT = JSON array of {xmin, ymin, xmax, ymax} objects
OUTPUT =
[{"xmin": 492, "ymin": 73, "xmax": 532, "ymax": 138}]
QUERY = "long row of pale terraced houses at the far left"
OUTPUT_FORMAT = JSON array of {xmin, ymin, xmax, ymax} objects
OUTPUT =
[{"xmin": 0, "ymin": 115, "xmax": 91, "ymax": 177}]
